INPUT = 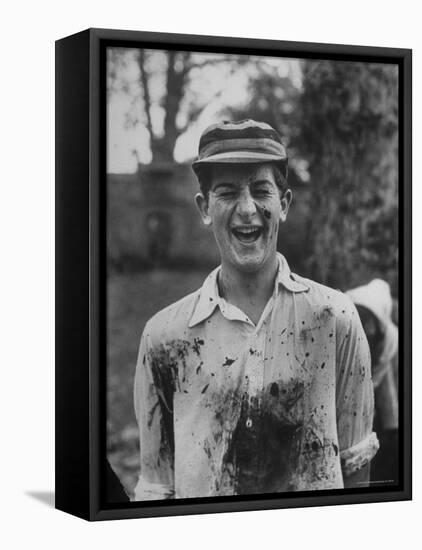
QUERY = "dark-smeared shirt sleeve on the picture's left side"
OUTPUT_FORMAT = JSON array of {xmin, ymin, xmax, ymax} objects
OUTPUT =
[{"xmin": 134, "ymin": 328, "xmax": 174, "ymax": 500}]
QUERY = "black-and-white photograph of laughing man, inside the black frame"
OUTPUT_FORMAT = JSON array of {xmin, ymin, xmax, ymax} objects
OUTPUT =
[{"xmin": 103, "ymin": 44, "xmax": 404, "ymax": 504}]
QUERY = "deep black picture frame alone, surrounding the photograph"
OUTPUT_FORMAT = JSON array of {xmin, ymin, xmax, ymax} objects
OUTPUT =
[{"xmin": 56, "ymin": 29, "xmax": 412, "ymax": 521}]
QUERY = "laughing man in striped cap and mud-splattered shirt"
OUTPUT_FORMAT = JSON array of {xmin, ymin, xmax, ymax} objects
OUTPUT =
[{"xmin": 134, "ymin": 120, "xmax": 378, "ymax": 500}]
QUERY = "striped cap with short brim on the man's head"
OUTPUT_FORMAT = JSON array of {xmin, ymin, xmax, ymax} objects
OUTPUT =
[{"xmin": 192, "ymin": 119, "xmax": 287, "ymax": 173}]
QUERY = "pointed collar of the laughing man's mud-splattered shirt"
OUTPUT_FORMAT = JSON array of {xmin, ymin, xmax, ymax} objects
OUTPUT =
[{"xmin": 189, "ymin": 253, "xmax": 309, "ymax": 328}]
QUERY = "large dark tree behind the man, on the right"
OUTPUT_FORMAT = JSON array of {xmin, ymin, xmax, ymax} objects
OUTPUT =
[{"xmin": 301, "ymin": 61, "xmax": 398, "ymax": 290}]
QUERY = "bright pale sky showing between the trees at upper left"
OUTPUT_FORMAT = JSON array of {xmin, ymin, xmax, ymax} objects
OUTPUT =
[{"xmin": 107, "ymin": 48, "xmax": 301, "ymax": 173}]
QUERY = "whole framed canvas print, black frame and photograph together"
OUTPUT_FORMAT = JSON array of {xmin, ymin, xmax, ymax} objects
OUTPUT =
[{"xmin": 56, "ymin": 29, "xmax": 411, "ymax": 520}]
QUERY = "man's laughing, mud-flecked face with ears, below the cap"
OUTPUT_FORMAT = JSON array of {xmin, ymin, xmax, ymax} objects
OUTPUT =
[{"xmin": 196, "ymin": 164, "xmax": 291, "ymax": 272}]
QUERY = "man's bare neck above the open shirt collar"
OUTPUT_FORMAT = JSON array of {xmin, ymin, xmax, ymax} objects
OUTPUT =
[{"xmin": 218, "ymin": 257, "xmax": 279, "ymax": 324}]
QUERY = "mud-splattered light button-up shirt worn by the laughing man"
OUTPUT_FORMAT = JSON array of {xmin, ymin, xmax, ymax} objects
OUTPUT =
[{"xmin": 134, "ymin": 255, "xmax": 376, "ymax": 500}]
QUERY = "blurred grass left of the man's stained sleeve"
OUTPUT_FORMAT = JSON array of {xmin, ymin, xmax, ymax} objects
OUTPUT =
[{"xmin": 107, "ymin": 269, "xmax": 208, "ymax": 494}]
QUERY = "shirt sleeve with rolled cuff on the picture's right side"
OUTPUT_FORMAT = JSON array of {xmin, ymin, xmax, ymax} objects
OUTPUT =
[{"xmin": 336, "ymin": 300, "xmax": 379, "ymax": 478}]
